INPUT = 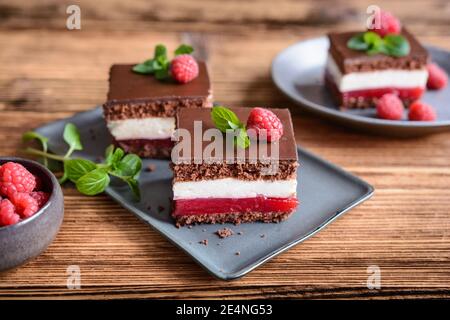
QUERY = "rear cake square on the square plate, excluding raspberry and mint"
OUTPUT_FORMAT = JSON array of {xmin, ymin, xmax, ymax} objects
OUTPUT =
[{"xmin": 103, "ymin": 62, "xmax": 212, "ymax": 158}]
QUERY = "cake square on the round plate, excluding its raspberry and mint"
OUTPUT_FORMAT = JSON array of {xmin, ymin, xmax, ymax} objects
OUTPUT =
[{"xmin": 325, "ymin": 28, "xmax": 428, "ymax": 108}]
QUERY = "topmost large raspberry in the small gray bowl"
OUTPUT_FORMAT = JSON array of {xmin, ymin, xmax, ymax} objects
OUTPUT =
[{"xmin": 0, "ymin": 162, "xmax": 36, "ymax": 198}]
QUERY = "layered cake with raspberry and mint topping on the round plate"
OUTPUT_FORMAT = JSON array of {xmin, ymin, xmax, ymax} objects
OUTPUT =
[{"xmin": 325, "ymin": 11, "xmax": 428, "ymax": 108}]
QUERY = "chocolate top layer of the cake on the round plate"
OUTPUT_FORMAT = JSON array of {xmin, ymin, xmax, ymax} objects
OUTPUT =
[{"xmin": 328, "ymin": 28, "xmax": 428, "ymax": 73}]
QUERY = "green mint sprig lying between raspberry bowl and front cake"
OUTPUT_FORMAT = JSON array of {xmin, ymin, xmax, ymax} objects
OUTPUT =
[{"xmin": 23, "ymin": 123, "xmax": 142, "ymax": 200}]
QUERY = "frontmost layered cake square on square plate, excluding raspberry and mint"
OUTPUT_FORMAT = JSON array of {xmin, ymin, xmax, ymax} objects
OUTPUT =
[{"xmin": 171, "ymin": 108, "xmax": 298, "ymax": 226}]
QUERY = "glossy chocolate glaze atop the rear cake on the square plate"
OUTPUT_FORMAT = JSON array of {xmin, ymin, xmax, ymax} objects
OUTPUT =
[{"xmin": 107, "ymin": 62, "xmax": 210, "ymax": 102}]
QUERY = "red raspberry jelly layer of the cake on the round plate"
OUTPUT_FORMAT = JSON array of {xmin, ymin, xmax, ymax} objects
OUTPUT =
[{"xmin": 341, "ymin": 87, "xmax": 425, "ymax": 102}]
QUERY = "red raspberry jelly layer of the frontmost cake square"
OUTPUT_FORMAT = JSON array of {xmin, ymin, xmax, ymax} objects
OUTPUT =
[{"xmin": 172, "ymin": 196, "xmax": 298, "ymax": 216}]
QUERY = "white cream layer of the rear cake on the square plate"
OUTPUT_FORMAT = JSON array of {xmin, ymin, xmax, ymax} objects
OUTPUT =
[{"xmin": 107, "ymin": 117, "xmax": 175, "ymax": 140}]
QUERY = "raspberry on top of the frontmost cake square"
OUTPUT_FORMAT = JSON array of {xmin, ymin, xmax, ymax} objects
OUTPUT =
[{"xmin": 247, "ymin": 108, "xmax": 283, "ymax": 142}]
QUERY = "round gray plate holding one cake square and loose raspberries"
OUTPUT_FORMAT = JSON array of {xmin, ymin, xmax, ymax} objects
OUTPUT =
[{"xmin": 272, "ymin": 36, "xmax": 450, "ymax": 136}]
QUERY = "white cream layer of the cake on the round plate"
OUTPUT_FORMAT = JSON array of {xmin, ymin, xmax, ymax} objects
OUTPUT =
[{"xmin": 326, "ymin": 55, "xmax": 428, "ymax": 92}]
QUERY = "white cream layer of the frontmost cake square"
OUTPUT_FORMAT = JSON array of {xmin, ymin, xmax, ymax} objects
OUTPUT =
[{"xmin": 173, "ymin": 178, "xmax": 297, "ymax": 200}]
